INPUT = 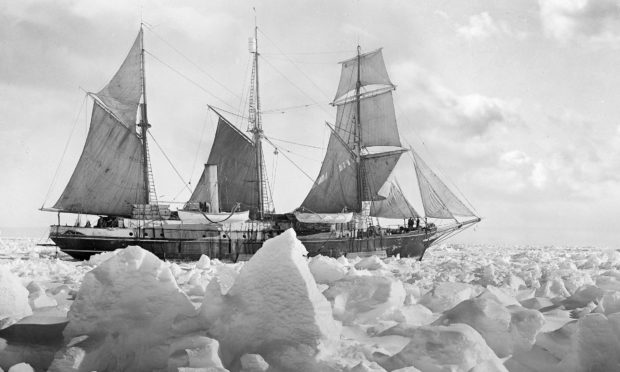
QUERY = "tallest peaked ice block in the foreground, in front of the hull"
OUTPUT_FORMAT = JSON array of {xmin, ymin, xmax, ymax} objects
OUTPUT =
[{"xmin": 201, "ymin": 229, "xmax": 340, "ymax": 370}]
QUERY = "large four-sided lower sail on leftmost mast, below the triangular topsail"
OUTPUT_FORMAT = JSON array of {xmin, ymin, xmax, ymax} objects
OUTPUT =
[{"xmin": 54, "ymin": 101, "xmax": 146, "ymax": 217}]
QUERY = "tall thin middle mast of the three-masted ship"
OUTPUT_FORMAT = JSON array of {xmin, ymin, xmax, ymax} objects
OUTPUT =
[{"xmin": 250, "ymin": 21, "xmax": 265, "ymax": 220}]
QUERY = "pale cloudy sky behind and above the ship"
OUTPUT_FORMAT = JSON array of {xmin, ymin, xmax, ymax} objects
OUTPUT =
[{"xmin": 0, "ymin": 0, "xmax": 620, "ymax": 247}]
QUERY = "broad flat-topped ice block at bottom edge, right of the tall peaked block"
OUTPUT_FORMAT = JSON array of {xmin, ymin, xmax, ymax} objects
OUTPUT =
[{"xmin": 376, "ymin": 324, "xmax": 507, "ymax": 372}]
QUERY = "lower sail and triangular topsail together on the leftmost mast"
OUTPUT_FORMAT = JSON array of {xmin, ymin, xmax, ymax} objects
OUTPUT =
[{"xmin": 54, "ymin": 30, "xmax": 148, "ymax": 216}]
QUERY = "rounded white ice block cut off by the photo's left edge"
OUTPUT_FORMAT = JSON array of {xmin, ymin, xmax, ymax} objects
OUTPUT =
[{"xmin": 0, "ymin": 266, "xmax": 32, "ymax": 329}]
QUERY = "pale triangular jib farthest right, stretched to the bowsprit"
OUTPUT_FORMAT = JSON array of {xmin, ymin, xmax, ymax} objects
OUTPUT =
[{"xmin": 412, "ymin": 150, "xmax": 476, "ymax": 219}]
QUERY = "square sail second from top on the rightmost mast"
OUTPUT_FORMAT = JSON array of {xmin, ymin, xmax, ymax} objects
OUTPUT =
[{"xmin": 336, "ymin": 91, "xmax": 401, "ymax": 147}]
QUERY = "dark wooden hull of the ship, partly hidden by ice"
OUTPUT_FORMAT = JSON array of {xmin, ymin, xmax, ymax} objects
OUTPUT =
[{"xmin": 50, "ymin": 226, "xmax": 435, "ymax": 261}]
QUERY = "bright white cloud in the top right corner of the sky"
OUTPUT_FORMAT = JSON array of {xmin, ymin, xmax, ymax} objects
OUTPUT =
[{"xmin": 539, "ymin": 0, "xmax": 620, "ymax": 43}]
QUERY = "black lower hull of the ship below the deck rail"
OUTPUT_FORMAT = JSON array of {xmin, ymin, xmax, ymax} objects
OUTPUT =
[{"xmin": 50, "ymin": 230, "xmax": 435, "ymax": 261}]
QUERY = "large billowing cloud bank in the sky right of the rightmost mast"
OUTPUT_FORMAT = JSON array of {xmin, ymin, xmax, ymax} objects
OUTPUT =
[{"xmin": 393, "ymin": 63, "xmax": 620, "ymax": 202}]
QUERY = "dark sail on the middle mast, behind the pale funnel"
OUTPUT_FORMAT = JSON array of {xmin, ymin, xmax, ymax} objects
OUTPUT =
[{"xmin": 189, "ymin": 114, "xmax": 259, "ymax": 215}]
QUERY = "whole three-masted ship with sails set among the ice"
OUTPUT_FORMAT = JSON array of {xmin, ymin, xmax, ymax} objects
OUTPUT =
[{"xmin": 42, "ymin": 27, "xmax": 480, "ymax": 261}]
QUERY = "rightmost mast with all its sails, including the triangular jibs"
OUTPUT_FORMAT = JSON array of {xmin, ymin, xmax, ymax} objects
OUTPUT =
[{"xmin": 301, "ymin": 46, "xmax": 479, "ymax": 229}]
